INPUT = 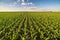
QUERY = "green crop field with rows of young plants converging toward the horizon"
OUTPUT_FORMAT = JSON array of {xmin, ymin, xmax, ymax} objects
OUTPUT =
[{"xmin": 0, "ymin": 12, "xmax": 60, "ymax": 40}]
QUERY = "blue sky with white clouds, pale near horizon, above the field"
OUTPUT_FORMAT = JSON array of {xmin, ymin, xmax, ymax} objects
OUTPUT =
[{"xmin": 0, "ymin": 0, "xmax": 60, "ymax": 11}]
